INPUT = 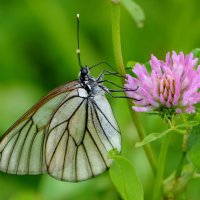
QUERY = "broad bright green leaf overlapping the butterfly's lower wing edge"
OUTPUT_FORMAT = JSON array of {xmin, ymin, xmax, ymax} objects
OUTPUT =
[{"xmin": 109, "ymin": 155, "xmax": 144, "ymax": 200}]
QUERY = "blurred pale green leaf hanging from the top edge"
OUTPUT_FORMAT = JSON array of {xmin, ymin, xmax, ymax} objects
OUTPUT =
[{"xmin": 121, "ymin": 0, "xmax": 145, "ymax": 28}]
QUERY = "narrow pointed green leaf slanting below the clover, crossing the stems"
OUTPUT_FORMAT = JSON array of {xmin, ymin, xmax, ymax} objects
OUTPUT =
[{"xmin": 135, "ymin": 128, "xmax": 173, "ymax": 147}]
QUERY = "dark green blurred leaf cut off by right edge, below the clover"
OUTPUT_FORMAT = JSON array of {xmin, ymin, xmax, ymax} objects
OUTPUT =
[{"xmin": 187, "ymin": 125, "xmax": 200, "ymax": 169}]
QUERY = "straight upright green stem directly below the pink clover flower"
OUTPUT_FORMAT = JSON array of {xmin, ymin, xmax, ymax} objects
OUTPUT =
[{"xmin": 153, "ymin": 134, "xmax": 171, "ymax": 200}]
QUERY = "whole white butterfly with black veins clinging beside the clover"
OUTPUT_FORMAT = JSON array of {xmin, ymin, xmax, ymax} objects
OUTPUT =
[{"xmin": 0, "ymin": 14, "xmax": 121, "ymax": 182}]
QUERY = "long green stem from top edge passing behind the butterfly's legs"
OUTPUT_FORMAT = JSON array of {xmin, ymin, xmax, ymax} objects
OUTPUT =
[{"xmin": 112, "ymin": 0, "xmax": 156, "ymax": 174}]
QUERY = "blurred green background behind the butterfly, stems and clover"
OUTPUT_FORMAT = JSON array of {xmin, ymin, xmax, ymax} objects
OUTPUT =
[{"xmin": 0, "ymin": 0, "xmax": 200, "ymax": 200}]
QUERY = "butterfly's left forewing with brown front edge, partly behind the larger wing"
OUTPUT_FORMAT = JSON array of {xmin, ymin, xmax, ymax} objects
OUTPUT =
[{"xmin": 0, "ymin": 81, "xmax": 78, "ymax": 174}]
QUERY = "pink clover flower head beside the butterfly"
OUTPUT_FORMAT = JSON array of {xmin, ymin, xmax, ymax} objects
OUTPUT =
[{"xmin": 125, "ymin": 51, "xmax": 200, "ymax": 113}]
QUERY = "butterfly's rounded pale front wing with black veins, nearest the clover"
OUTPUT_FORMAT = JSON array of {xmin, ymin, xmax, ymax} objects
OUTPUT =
[{"xmin": 45, "ymin": 89, "xmax": 121, "ymax": 182}]
